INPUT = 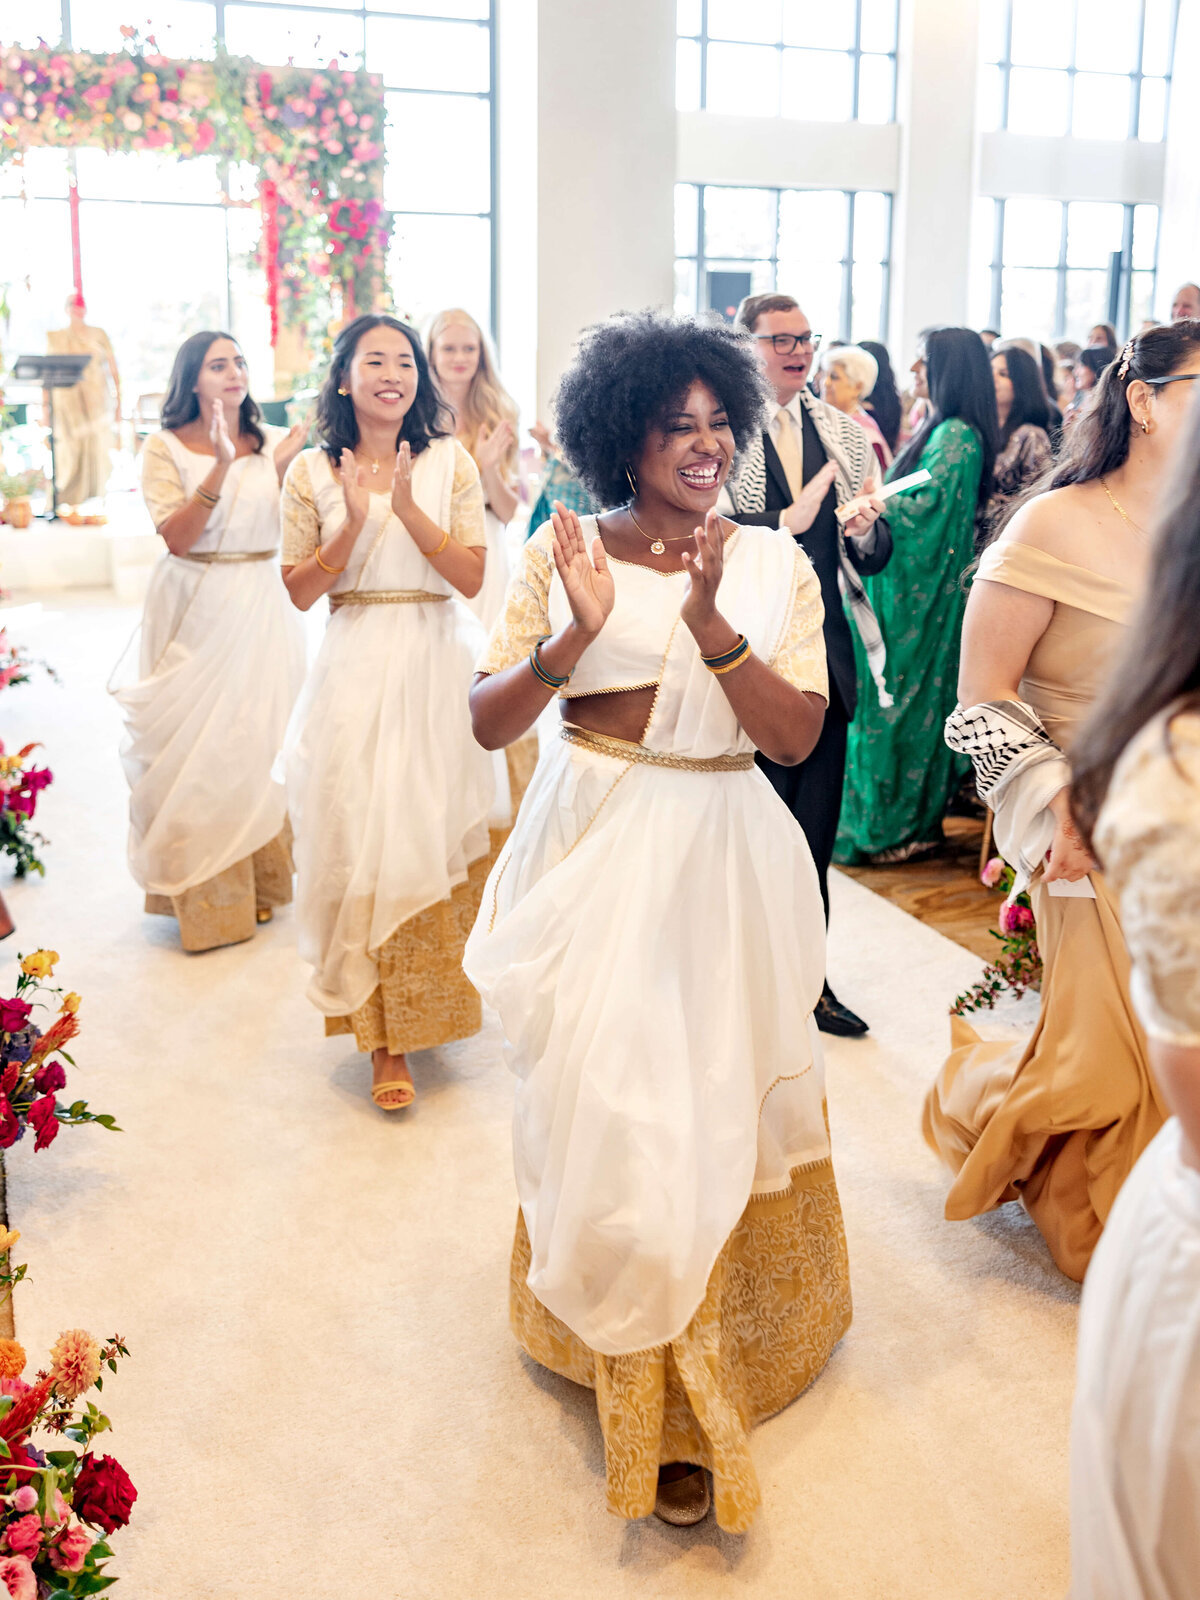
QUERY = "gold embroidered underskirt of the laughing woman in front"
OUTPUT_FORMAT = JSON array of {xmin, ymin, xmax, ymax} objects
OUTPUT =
[{"xmin": 509, "ymin": 1158, "xmax": 851, "ymax": 1533}]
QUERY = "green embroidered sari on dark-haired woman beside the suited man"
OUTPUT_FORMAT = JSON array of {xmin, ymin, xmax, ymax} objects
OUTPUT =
[{"xmin": 834, "ymin": 418, "xmax": 982, "ymax": 864}]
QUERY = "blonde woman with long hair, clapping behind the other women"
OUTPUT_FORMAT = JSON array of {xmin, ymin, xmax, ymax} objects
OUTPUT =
[{"xmin": 426, "ymin": 307, "xmax": 520, "ymax": 627}]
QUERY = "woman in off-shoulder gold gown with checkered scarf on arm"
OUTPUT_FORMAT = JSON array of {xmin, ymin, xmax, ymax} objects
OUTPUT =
[{"xmin": 925, "ymin": 322, "xmax": 1200, "ymax": 1278}]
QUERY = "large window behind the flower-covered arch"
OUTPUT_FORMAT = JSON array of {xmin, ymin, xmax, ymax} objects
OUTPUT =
[{"xmin": 0, "ymin": 0, "xmax": 494, "ymax": 395}]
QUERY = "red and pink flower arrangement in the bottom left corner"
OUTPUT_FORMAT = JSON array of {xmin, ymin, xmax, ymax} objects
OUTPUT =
[{"xmin": 0, "ymin": 1312, "xmax": 138, "ymax": 1600}]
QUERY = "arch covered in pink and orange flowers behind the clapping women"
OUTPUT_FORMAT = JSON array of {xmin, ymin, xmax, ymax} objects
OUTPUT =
[{"xmin": 0, "ymin": 26, "xmax": 390, "ymax": 346}]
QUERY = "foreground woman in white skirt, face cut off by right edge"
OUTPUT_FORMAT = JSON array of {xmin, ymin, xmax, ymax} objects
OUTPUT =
[{"xmin": 1070, "ymin": 384, "xmax": 1200, "ymax": 1597}]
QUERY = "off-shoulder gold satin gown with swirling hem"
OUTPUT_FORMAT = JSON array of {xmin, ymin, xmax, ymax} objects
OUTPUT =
[{"xmin": 922, "ymin": 542, "xmax": 1165, "ymax": 1282}]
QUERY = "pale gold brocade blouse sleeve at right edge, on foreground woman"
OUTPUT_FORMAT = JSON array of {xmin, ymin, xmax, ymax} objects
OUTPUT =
[{"xmin": 1096, "ymin": 710, "xmax": 1200, "ymax": 1048}]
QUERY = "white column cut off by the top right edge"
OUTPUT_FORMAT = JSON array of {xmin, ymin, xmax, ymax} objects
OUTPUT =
[{"xmin": 1155, "ymin": 0, "xmax": 1200, "ymax": 318}]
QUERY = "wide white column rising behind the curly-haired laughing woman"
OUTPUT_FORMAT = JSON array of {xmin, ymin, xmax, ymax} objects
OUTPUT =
[{"xmin": 534, "ymin": 0, "xmax": 675, "ymax": 416}]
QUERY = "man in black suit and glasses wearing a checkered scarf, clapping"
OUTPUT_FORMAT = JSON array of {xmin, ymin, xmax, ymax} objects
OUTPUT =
[{"xmin": 728, "ymin": 294, "xmax": 891, "ymax": 1037}]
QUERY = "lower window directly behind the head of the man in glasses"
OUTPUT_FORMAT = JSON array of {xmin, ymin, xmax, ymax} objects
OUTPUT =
[{"xmin": 675, "ymin": 184, "xmax": 891, "ymax": 339}]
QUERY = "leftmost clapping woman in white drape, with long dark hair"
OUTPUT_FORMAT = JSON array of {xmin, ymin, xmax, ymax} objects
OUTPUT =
[{"xmin": 110, "ymin": 333, "xmax": 306, "ymax": 950}]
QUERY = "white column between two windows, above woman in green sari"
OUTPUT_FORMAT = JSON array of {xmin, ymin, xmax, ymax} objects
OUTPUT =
[{"xmin": 888, "ymin": 0, "xmax": 979, "ymax": 361}]
